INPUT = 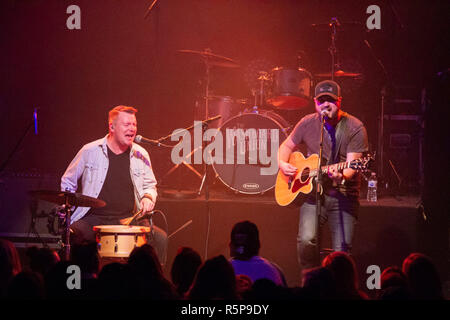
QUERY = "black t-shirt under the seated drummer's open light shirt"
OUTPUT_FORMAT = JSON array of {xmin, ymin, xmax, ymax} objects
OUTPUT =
[{"xmin": 90, "ymin": 147, "xmax": 134, "ymax": 218}]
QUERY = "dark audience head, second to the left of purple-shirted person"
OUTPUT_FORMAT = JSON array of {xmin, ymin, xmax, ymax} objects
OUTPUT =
[{"xmin": 170, "ymin": 247, "xmax": 202, "ymax": 296}]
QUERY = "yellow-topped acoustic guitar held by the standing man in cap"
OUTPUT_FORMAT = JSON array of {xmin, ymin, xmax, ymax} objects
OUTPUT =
[{"xmin": 275, "ymin": 152, "xmax": 373, "ymax": 206}]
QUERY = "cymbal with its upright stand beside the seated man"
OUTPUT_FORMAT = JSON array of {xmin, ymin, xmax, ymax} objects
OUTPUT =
[{"xmin": 30, "ymin": 190, "xmax": 106, "ymax": 261}]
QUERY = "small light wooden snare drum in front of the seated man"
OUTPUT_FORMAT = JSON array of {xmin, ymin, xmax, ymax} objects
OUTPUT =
[{"xmin": 94, "ymin": 225, "xmax": 150, "ymax": 258}]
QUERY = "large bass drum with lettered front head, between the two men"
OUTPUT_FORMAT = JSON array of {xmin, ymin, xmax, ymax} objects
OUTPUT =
[{"xmin": 212, "ymin": 111, "xmax": 291, "ymax": 194}]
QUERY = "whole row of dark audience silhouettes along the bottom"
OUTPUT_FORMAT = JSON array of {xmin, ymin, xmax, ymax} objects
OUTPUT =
[{"xmin": 0, "ymin": 221, "xmax": 444, "ymax": 301}]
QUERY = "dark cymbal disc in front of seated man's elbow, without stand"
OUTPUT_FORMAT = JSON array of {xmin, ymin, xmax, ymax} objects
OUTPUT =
[{"xmin": 29, "ymin": 190, "xmax": 106, "ymax": 208}]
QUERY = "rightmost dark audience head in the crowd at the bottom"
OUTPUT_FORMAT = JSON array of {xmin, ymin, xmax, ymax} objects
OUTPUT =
[{"xmin": 402, "ymin": 253, "xmax": 443, "ymax": 300}]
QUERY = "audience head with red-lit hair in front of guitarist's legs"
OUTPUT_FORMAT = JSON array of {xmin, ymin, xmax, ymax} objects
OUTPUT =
[{"xmin": 322, "ymin": 251, "xmax": 367, "ymax": 299}]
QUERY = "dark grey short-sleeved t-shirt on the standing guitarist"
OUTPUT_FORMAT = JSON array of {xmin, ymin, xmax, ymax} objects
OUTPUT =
[{"xmin": 290, "ymin": 112, "xmax": 369, "ymax": 198}]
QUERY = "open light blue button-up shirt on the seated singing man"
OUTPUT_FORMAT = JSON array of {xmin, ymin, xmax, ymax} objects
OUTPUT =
[{"xmin": 61, "ymin": 135, "xmax": 158, "ymax": 223}]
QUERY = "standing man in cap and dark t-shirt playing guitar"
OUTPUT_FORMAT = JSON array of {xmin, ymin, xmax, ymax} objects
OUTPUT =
[{"xmin": 277, "ymin": 80, "xmax": 368, "ymax": 269}]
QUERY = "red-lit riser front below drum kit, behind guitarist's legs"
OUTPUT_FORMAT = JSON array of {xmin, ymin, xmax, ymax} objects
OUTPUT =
[{"xmin": 154, "ymin": 188, "xmax": 423, "ymax": 292}]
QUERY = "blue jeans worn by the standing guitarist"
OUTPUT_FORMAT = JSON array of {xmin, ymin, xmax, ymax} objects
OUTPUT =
[{"xmin": 297, "ymin": 192, "xmax": 359, "ymax": 269}]
